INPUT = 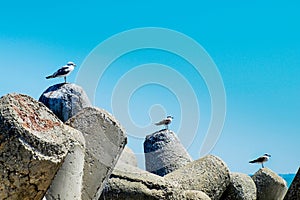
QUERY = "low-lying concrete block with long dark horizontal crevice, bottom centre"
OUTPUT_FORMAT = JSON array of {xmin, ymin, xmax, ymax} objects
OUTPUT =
[{"xmin": 100, "ymin": 164, "xmax": 210, "ymax": 200}]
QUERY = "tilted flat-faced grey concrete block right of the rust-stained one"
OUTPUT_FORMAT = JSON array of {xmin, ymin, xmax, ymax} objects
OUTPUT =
[{"xmin": 66, "ymin": 107, "xmax": 127, "ymax": 200}]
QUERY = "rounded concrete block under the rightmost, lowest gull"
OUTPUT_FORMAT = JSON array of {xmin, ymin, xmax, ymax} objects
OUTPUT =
[{"xmin": 252, "ymin": 168, "xmax": 287, "ymax": 200}]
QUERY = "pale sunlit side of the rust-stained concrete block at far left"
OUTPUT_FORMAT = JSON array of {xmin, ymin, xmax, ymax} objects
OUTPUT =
[{"xmin": 46, "ymin": 126, "xmax": 85, "ymax": 200}]
